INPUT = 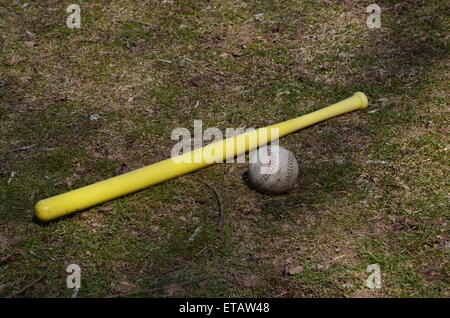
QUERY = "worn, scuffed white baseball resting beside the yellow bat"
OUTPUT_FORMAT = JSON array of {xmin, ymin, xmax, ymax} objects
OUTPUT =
[{"xmin": 248, "ymin": 145, "xmax": 299, "ymax": 194}]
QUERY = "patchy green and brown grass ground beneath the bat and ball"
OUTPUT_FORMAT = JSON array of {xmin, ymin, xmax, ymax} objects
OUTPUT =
[{"xmin": 0, "ymin": 0, "xmax": 449, "ymax": 297}]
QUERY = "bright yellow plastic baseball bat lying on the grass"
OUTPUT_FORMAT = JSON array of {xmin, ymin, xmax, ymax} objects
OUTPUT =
[{"xmin": 35, "ymin": 92, "xmax": 368, "ymax": 221}]
